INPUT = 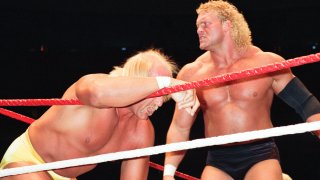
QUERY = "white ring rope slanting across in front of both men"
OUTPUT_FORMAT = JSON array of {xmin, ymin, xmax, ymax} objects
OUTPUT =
[{"xmin": 0, "ymin": 121, "xmax": 320, "ymax": 177}]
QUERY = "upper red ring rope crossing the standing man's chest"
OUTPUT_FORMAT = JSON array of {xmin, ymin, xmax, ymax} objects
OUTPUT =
[{"xmin": 0, "ymin": 53, "xmax": 320, "ymax": 107}]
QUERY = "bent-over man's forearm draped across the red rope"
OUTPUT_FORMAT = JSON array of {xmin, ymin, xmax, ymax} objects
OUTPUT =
[{"xmin": 75, "ymin": 75, "xmax": 165, "ymax": 108}]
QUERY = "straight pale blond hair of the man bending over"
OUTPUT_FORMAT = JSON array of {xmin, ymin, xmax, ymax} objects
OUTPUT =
[{"xmin": 109, "ymin": 49, "xmax": 178, "ymax": 77}]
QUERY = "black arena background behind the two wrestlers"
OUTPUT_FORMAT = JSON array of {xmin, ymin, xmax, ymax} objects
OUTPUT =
[{"xmin": 0, "ymin": 0, "xmax": 320, "ymax": 180}]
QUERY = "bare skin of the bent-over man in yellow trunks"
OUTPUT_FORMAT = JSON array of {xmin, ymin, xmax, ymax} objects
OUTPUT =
[{"xmin": 0, "ymin": 51, "xmax": 199, "ymax": 180}]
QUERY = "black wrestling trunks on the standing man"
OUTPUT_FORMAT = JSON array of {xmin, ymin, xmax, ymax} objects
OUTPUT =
[{"xmin": 207, "ymin": 138, "xmax": 280, "ymax": 180}]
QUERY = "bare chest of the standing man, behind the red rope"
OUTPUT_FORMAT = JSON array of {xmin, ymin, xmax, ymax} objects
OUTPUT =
[{"xmin": 191, "ymin": 60, "xmax": 272, "ymax": 107}]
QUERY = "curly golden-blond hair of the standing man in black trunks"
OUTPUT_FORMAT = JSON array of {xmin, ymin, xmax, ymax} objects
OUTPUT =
[{"xmin": 196, "ymin": 0, "xmax": 252, "ymax": 49}]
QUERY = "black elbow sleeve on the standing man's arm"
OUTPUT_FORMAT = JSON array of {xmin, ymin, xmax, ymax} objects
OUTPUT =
[{"xmin": 278, "ymin": 77, "xmax": 320, "ymax": 121}]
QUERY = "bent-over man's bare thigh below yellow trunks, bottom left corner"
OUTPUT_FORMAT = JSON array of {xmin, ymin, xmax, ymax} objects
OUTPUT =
[{"xmin": 1, "ymin": 162, "xmax": 52, "ymax": 180}]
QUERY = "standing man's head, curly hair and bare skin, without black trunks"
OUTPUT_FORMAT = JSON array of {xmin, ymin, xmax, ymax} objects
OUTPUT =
[{"xmin": 163, "ymin": 4, "xmax": 320, "ymax": 180}]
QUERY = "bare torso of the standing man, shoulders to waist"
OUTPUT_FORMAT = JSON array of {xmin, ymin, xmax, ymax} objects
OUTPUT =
[{"xmin": 179, "ymin": 47, "xmax": 293, "ymax": 137}]
